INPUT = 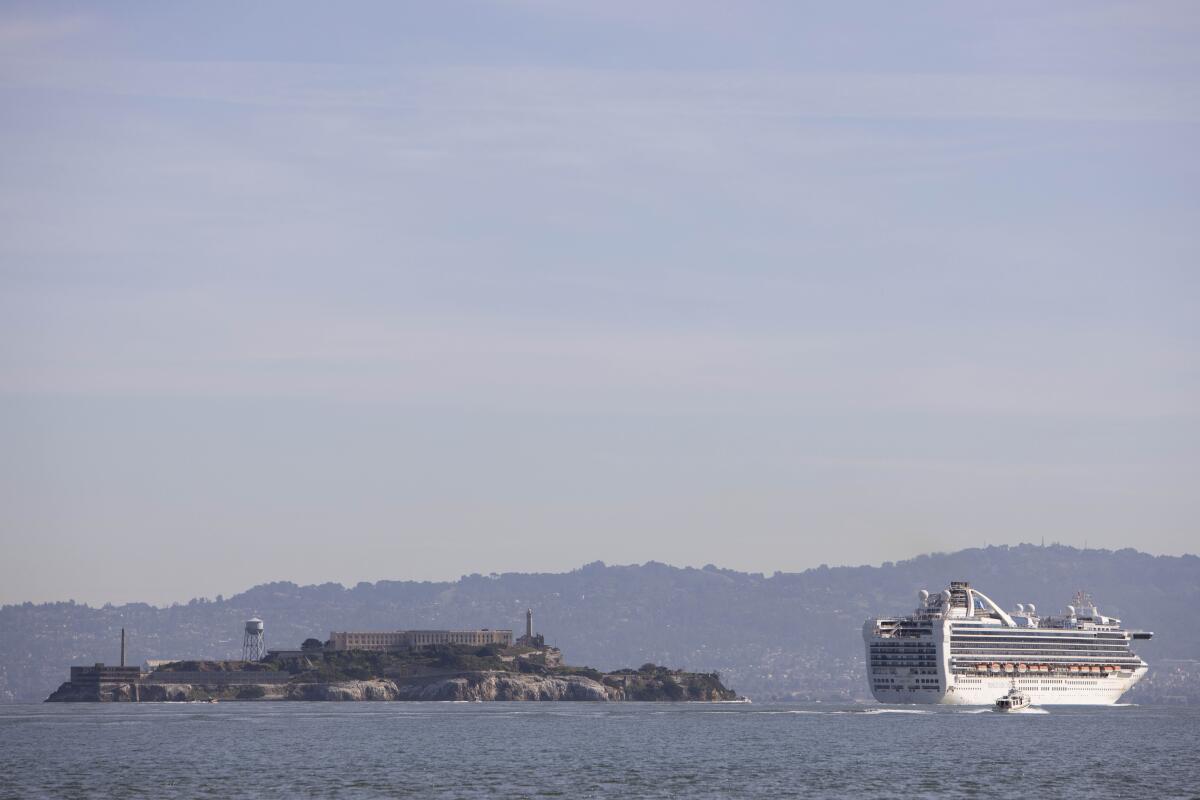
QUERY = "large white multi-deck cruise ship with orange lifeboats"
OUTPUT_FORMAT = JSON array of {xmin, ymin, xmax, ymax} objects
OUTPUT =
[{"xmin": 863, "ymin": 581, "xmax": 1152, "ymax": 705}]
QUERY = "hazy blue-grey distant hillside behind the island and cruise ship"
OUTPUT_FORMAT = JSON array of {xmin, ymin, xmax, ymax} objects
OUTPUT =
[{"xmin": 0, "ymin": 545, "xmax": 1200, "ymax": 703}]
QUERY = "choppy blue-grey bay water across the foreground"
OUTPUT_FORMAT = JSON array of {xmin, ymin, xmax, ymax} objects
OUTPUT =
[{"xmin": 0, "ymin": 703, "xmax": 1200, "ymax": 800}]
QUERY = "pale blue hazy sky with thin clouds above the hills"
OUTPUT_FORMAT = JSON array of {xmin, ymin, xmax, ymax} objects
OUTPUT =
[{"xmin": 0, "ymin": 0, "xmax": 1200, "ymax": 603}]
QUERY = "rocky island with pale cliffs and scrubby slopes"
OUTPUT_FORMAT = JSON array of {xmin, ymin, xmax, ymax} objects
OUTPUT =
[{"xmin": 47, "ymin": 640, "xmax": 738, "ymax": 703}]
